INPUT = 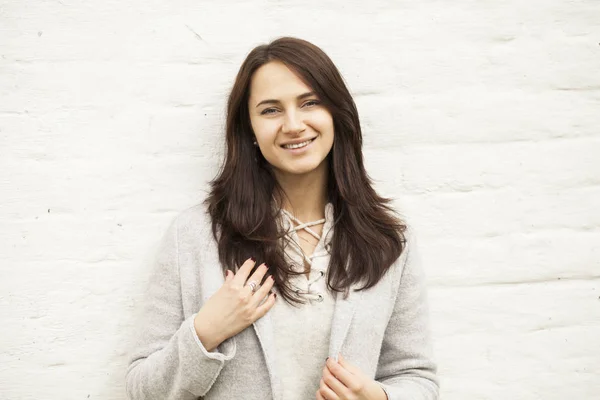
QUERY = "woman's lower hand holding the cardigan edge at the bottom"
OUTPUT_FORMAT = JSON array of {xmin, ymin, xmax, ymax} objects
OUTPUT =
[{"xmin": 317, "ymin": 354, "xmax": 387, "ymax": 400}]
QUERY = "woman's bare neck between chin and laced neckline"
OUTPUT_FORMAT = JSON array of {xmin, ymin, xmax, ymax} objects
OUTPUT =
[{"xmin": 275, "ymin": 161, "xmax": 327, "ymax": 222}]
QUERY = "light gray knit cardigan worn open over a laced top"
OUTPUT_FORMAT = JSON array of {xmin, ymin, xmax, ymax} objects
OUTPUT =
[{"xmin": 126, "ymin": 205, "xmax": 438, "ymax": 400}]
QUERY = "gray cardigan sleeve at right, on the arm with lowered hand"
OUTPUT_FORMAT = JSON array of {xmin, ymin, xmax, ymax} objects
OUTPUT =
[{"xmin": 375, "ymin": 231, "xmax": 439, "ymax": 400}]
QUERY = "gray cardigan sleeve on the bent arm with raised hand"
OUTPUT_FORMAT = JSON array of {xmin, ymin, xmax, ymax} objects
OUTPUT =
[{"xmin": 126, "ymin": 219, "xmax": 236, "ymax": 400}]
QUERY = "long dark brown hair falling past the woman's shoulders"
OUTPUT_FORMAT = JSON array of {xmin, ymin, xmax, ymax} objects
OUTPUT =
[{"xmin": 205, "ymin": 37, "xmax": 406, "ymax": 304}]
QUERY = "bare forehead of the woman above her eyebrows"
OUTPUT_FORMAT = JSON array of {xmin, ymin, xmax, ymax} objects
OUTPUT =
[{"xmin": 249, "ymin": 61, "xmax": 311, "ymax": 104}]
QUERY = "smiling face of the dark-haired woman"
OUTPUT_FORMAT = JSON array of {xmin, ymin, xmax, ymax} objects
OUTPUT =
[{"xmin": 248, "ymin": 61, "xmax": 334, "ymax": 180}]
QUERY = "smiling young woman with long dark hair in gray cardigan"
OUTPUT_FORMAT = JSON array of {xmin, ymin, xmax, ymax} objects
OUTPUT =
[{"xmin": 127, "ymin": 37, "xmax": 438, "ymax": 400}]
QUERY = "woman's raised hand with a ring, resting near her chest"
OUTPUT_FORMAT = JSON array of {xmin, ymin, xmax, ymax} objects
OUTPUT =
[{"xmin": 194, "ymin": 258, "xmax": 277, "ymax": 351}]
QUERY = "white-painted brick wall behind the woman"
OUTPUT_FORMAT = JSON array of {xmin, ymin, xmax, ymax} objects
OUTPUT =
[{"xmin": 0, "ymin": 0, "xmax": 600, "ymax": 400}]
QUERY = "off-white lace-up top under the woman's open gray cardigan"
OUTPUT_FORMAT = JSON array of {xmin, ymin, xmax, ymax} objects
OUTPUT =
[{"xmin": 269, "ymin": 203, "xmax": 335, "ymax": 400}]
